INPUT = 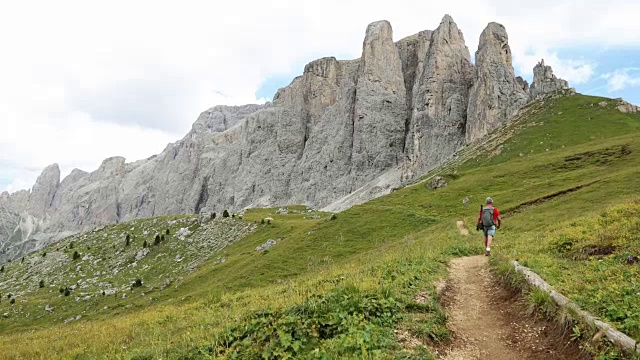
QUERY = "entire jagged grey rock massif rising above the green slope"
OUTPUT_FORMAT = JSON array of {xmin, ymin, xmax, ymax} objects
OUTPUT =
[{"xmin": 0, "ymin": 15, "xmax": 567, "ymax": 263}]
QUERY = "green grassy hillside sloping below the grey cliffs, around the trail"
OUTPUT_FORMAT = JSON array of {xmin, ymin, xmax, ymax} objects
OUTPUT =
[{"xmin": 0, "ymin": 95, "xmax": 640, "ymax": 359}]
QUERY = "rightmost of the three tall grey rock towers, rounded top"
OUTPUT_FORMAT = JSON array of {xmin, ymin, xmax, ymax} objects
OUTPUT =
[{"xmin": 466, "ymin": 23, "xmax": 529, "ymax": 142}]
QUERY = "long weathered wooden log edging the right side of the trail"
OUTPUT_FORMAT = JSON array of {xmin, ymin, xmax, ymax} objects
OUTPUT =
[{"xmin": 512, "ymin": 260, "xmax": 640, "ymax": 354}]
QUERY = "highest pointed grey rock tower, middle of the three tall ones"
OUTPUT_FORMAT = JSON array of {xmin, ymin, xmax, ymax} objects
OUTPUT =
[{"xmin": 403, "ymin": 15, "xmax": 473, "ymax": 178}]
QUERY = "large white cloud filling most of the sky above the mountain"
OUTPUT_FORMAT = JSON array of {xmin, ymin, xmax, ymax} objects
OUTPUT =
[{"xmin": 0, "ymin": 0, "xmax": 640, "ymax": 191}]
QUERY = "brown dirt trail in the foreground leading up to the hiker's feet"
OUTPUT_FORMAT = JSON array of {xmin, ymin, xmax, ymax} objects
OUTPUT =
[{"xmin": 437, "ymin": 256, "xmax": 590, "ymax": 360}]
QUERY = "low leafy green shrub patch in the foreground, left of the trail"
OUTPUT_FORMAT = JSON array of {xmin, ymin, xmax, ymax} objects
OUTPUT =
[{"xmin": 208, "ymin": 287, "xmax": 402, "ymax": 359}]
